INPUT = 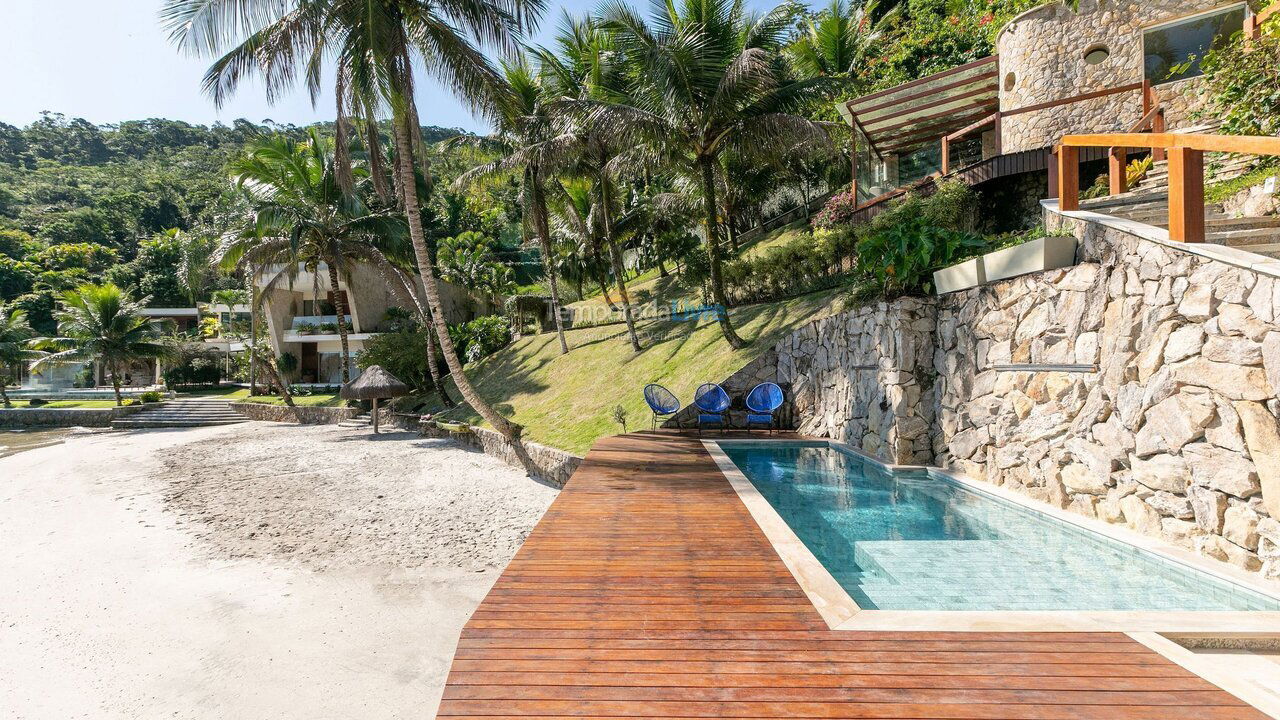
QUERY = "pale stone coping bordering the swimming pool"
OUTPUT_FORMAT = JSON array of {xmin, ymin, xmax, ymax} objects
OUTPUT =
[{"xmin": 703, "ymin": 438, "xmax": 1280, "ymax": 630}]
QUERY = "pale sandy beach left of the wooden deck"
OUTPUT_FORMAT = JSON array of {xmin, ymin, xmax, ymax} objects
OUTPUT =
[{"xmin": 0, "ymin": 423, "xmax": 554, "ymax": 720}]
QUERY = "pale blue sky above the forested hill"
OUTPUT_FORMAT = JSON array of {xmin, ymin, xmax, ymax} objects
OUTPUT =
[{"xmin": 0, "ymin": 0, "xmax": 788, "ymax": 132}]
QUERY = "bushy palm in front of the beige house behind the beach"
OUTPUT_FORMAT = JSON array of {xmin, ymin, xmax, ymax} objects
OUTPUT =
[{"xmin": 216, "ymin": 129, "xmax": 403, "ymax": 384}]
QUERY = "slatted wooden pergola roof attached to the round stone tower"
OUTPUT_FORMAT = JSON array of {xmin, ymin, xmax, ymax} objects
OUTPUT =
[{"xmin": 840, "ymin": 55, "xmax": 1000, "ymax": 155}]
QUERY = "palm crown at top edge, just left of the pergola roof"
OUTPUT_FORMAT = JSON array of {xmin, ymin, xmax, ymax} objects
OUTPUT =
[{"xmin": 786, "ymin": 0, "xmax": 902, "ymax": 77}]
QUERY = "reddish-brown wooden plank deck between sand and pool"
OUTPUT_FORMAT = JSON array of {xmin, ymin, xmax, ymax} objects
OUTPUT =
[{"xmin": 439, "ymin": 434, "xmax": 1265, "ymax": 720}]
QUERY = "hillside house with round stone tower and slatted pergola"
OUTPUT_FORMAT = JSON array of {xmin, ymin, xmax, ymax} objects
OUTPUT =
[{"xmin": 838, "ymin": 0, "xmax": 1252, "ymax": 214}]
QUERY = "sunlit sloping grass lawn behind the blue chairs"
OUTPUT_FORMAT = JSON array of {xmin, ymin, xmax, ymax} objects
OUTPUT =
[{"xmin": 428, "ymin": 291, "xmax": 841, "ymax": 455}]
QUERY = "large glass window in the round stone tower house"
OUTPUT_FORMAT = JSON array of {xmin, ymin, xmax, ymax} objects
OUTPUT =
[{"xmin": 1142, "ymin": 4, "xmax": 1244, "ymax": 85}]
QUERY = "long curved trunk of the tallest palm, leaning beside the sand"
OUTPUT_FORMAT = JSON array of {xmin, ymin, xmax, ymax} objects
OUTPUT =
[{"xmin": 393, "ymin": 110, "xmax": 520, "ymax": 439}]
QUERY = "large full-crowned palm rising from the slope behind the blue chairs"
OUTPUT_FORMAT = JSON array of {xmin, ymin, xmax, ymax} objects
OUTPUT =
[{"xmin": 572, "ymin": 0, "xmax": 829, "ymax": 347}]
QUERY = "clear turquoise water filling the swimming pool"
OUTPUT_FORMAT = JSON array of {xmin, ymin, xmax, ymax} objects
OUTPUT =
[{"xmin": 721, "ymin": 442, "xmax": 1280, "ymax": 610}]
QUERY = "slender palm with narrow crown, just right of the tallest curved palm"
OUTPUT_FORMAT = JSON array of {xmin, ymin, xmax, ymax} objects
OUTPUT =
[{"xmin": 454, "ymin": 55, "xmax": 568, "ymax": 355}]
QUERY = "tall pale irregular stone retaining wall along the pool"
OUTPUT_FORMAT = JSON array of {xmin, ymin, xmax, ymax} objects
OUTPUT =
[{"xmin": 750, "ymin": 210, "xmax": 1280, "ymax": 579}]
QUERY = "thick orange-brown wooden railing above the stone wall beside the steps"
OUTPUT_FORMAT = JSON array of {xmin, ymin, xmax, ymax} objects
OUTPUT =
[{"xmin": 1051, "ymin": 132, "xmax": 1280, "ymax": 242}]
